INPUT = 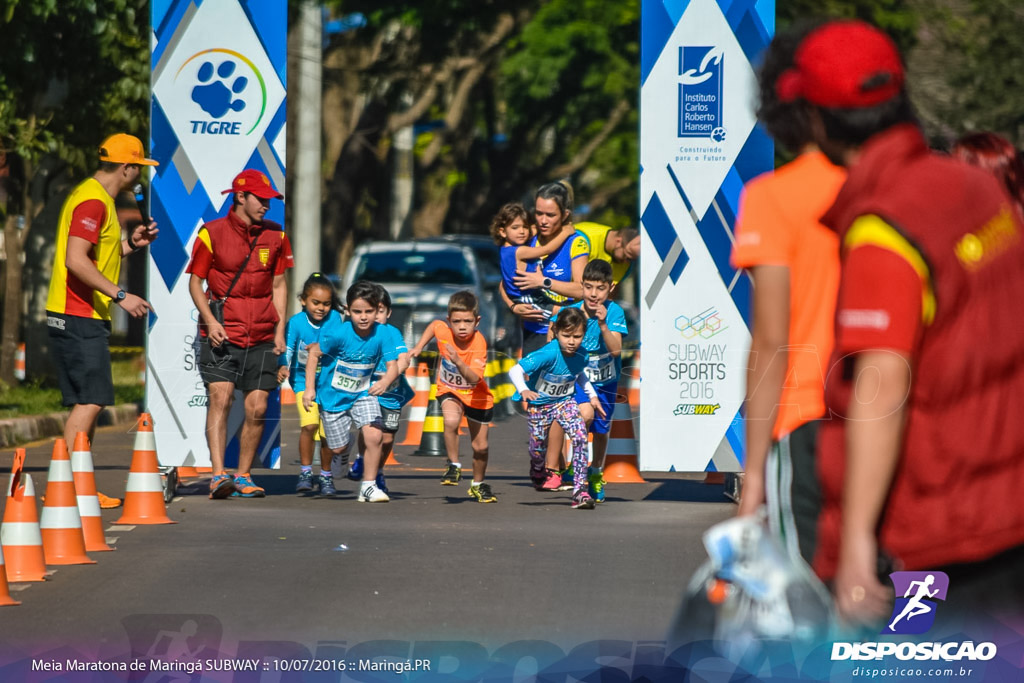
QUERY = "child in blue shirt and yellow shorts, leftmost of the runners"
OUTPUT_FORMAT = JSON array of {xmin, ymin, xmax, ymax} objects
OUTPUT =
[{"xmin": 278, "ymin": 272, "xmax": 341, "ymax": 493}]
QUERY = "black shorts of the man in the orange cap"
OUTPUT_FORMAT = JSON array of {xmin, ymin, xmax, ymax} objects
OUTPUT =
[{"xmin": 46, "ymin": 311, "xmax": 114, "ymax": 405}]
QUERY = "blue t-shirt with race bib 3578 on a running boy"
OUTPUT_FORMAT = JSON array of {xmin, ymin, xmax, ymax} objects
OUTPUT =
[{"xmin": 316, "ymin": 318, "xmax": 398, "ymax": 413}]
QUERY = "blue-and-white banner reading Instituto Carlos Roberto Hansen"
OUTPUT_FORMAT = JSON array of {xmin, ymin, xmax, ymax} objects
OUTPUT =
[{"xmin": 640, "ymin": 0, "xmax": 775, "ymax": 471}]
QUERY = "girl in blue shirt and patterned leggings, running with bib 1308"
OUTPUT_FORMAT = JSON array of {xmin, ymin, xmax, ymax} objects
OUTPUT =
[{"xmin": 509, "ymin": 308, "xmax": 605, "ymax": 510}]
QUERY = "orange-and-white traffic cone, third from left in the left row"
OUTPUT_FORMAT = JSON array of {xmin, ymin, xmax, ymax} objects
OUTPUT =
[{"xmin": 39, "ymin": 438, "xmax": 96, "ymax": 564}]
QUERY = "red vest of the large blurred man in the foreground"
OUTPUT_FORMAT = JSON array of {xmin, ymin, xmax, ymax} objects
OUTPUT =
[{"xmin": 814, "ymin": 125, "xmax": 1024, "ymax": 579}]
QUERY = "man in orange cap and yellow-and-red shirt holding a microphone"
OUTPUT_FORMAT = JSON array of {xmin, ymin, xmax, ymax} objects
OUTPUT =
[{"xmin": 46, "ymin": 133, "xmax": 159, "ymax": 508}]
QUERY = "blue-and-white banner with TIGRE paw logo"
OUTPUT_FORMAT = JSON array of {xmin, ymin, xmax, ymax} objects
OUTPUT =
[{"xmin": 145, "ymin": 0, "xmax": 288, "ymax": 467}]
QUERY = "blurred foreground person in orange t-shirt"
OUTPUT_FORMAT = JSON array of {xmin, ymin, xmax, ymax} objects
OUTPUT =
[{"xmin": 732, "ymin": 26, "xmax": 846, "ymax": 563}]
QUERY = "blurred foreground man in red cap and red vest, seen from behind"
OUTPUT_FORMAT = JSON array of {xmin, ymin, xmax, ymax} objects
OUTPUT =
[{"xmin": 775, "ymin": 20, "xmax": 1024, "ymax": 622}]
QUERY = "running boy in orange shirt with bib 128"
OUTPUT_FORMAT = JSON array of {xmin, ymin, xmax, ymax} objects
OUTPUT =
[{"xmin": 410, "ymin": 290, "xmax": 498, "ymax": 503}]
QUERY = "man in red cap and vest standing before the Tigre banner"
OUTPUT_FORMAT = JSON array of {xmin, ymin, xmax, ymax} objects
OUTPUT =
[{"xmin": 187, "ymin": 169, "xmax": 295, "ymax": 499}]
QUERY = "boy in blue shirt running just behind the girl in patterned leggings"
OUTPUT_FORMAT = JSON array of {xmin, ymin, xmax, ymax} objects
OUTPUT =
[{"xmin": 549, "ymin": 260, "xmax": 629, "ymax": 503}]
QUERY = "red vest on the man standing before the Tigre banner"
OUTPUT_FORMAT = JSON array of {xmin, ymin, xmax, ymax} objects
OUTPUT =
[{"xmin": 203, "ymin": 215, "xmax": 286, "ymax": 347}]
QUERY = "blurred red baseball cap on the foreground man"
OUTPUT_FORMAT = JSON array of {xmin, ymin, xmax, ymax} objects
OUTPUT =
[{"xmin": 775, "ymin": 20, "xmax": 905, "ymax": 109}]
